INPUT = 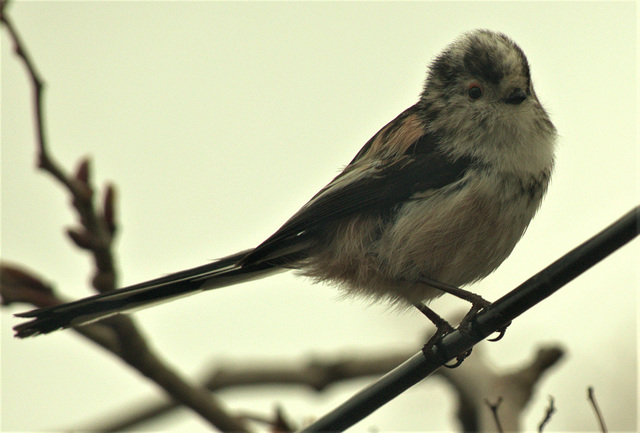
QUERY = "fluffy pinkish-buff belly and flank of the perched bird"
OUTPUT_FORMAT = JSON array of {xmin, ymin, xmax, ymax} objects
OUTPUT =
[{"xmin": 301, "ymin": 169, "xmax": 544, "ymax": 302}]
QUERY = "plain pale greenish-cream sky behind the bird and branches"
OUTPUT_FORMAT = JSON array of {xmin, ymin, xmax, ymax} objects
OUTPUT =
[{"xmin": 0, "ymin": 1, "xmax": 640, "ymax": 431}]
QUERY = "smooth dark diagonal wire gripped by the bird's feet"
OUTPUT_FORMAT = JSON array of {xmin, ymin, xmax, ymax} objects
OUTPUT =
[{"xmin": 302, "ymin": 206, "xmax": 640, "ymax": 433}]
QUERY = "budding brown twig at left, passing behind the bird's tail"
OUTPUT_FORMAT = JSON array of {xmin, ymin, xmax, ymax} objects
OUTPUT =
[{"xmin": 0, "ymin": 7, "xmax": 246, "ymax": 431}]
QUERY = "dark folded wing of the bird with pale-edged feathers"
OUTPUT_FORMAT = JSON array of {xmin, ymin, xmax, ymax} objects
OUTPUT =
[{"xmin": 240, "ymin": 109, "xmax": 473, "ymax": 266}]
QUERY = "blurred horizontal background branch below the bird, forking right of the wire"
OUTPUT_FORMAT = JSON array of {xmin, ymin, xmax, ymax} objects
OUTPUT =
[{"xmin": 93, "ymin": 347, "xmax": 562, "ymax": 432}]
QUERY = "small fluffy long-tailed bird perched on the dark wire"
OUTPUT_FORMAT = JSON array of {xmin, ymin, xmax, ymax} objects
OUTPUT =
[{"xmin": 14, "ymin": 30, "xmax": 556, "ymax": 337}]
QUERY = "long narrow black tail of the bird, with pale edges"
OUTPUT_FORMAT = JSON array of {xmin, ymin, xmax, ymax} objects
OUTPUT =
[{"xmin": 13, "ymin": 250, "xmax": 283, "ymax": 338}]
